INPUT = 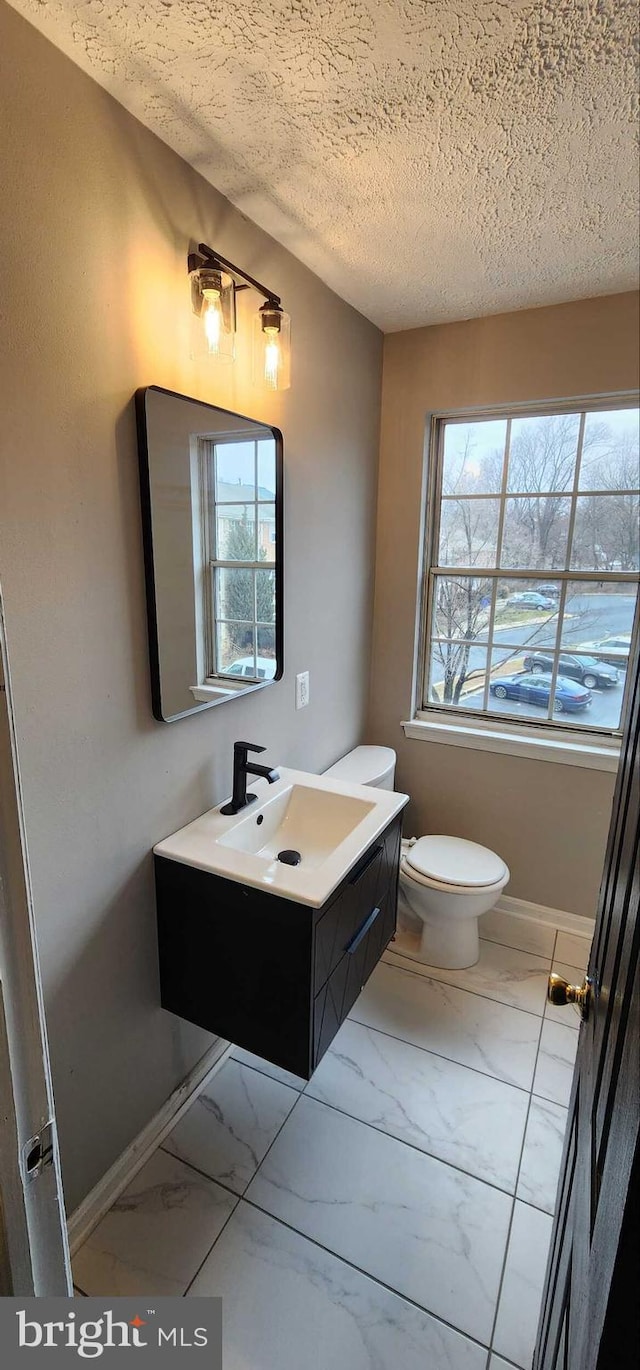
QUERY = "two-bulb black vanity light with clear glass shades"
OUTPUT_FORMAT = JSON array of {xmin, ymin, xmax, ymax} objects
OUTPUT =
[{"xmin": 186, "ymin": 242, "xmax": 291, "ymax": 390}]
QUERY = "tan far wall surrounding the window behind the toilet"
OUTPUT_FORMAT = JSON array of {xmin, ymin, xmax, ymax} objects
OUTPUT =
[{"xmin": 367, "ymin": 295, "xmax": 639, "ymax": 917}]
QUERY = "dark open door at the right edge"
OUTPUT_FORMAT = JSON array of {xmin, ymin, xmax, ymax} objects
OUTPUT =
[{"xmin": 533, "ymin": 632, "xmax": 640, "ymax": 1370}]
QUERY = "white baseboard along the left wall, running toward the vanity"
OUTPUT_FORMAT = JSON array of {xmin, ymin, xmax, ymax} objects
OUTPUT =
[{"xmin": 67, "ymin": 1040, "xmax": 232, "ymax": 1255}]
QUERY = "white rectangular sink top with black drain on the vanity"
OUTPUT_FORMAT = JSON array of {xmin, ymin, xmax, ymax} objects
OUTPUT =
[{"xmin": 153, "ymin": 769, "xmax": 408, "ymax": 908}]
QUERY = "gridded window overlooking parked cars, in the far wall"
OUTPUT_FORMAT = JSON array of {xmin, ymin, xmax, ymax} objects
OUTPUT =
[{"xmin": 419, "ymin": 401, "xmax": 640, "ymax": 740}]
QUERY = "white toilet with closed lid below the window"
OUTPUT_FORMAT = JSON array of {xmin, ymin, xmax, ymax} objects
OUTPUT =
[{"xmin": 325, "ymin": 747, "xmax": 508, "ymax": 970}]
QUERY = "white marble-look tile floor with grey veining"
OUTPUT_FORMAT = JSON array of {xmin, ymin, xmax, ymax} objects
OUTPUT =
[{"xmin": 74, "ymin": 911, "xmax": 589, "ymax": 1370}]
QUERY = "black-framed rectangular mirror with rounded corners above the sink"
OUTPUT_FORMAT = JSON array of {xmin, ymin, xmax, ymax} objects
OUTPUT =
[{"xmin": 136, "ymin": 385, "xmax": 284, "ymax": 723}]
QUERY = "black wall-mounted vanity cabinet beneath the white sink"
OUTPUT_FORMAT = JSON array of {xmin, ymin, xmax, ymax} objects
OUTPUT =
[{"xmin": 155, "ymin": 815, "xmax": 402, "ymax": 1080}]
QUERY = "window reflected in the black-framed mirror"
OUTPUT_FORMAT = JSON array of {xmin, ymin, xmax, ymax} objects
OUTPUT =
[{"xmin": 200, "ymin": 434, "xmax": 277, "ymax": 681}]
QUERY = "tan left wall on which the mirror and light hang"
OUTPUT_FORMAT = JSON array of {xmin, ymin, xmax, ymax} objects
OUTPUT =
[{"xmin": 0, "ymin": 4, "xmax": 381, "ymax": 1208}]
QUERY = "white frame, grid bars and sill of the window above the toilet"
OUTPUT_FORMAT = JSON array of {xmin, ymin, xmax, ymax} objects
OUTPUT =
[{"xmin": 402, "ymin": 392, "xmax": 640, "ymax": 771}]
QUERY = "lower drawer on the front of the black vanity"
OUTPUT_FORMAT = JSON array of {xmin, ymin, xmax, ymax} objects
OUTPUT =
[{"xmin": 312, "ymin": 889, "xmax": 396, "ymax": 1069}]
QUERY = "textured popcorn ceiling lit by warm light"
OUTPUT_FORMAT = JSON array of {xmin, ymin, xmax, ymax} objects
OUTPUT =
[{"xmin": 6, "ymin": 0, "xmax": 637, "ymax": 330}]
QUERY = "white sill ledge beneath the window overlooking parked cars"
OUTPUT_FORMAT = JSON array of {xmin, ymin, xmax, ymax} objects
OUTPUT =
[{"xmin": 402, "ymin": 714, "xmax": 619, "ymax": 771}]
